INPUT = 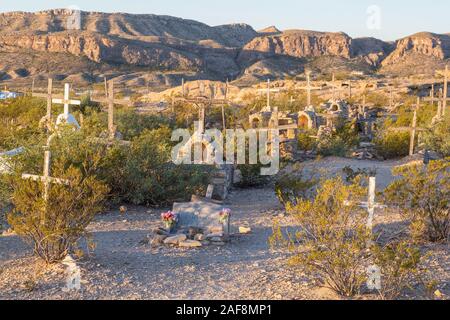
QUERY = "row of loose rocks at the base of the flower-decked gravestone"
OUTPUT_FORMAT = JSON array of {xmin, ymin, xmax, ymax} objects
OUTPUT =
[{"xmin": 149, "ymin": 227, "xmax": 230, "ymax": 248}]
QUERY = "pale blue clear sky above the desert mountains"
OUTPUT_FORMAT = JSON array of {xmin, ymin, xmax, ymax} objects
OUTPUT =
[{"xmin": 0, "ymin": 0, "xmax": 450, "ymax": 40}]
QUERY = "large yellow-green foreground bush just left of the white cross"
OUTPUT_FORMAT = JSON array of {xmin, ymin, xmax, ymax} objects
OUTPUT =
[{"xmin": 274, "ymin": 178, "xmax": 371, "ymax": 297}]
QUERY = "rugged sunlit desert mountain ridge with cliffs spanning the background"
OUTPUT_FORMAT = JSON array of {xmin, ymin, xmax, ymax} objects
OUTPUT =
[{"xmin": 0, "ymin": 9, "xmax": 450, "ymax": 86}]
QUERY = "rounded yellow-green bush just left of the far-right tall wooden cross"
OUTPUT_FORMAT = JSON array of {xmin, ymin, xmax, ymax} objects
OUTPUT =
[{"xmin": 374, "ymin": 131, "xmax": 410, "ymax": 159}]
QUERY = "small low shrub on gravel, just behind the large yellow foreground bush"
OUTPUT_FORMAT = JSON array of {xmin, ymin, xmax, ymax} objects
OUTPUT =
[{"xmin": 275, "ymin": 167, "xmax": 319, "ymax": 207}]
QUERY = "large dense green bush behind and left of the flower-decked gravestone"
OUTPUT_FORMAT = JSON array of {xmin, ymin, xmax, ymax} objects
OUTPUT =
[{"xmin": 103, "ymin": 127, "xmax": 211, "ymax": 205}]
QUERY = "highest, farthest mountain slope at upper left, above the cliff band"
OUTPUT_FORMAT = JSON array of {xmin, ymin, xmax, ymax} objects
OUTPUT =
[{"xmin": 0, "ymin": 9, "xmax": 258, "ymax": 47}]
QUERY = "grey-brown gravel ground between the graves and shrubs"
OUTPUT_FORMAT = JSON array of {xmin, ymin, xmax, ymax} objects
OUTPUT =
[{"xmin": 0, "ymin": 159, "xmax": 450, "ymax": 300}]
